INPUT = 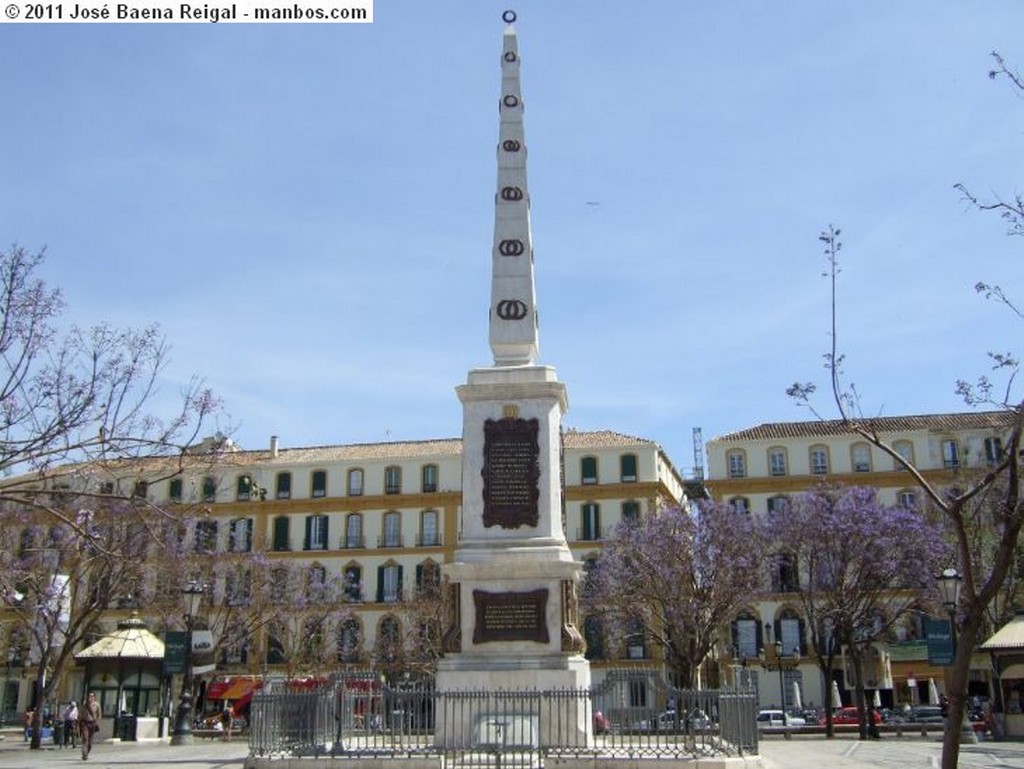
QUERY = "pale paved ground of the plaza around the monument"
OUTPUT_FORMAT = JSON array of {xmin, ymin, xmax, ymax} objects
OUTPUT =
[{"xmin": 0, "ymin": 735, "xmax": 1024, "ymax": 769}]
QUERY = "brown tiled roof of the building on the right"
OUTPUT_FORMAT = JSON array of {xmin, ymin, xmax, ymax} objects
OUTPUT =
[{"xmin": 713, "ymin": 411, "xmax": 1014, "ymax": 441}]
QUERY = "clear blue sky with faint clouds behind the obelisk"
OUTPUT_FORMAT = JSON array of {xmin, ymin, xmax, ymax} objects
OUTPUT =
[{"xmin": 0, "ymin": 0, "xmax": 1024, "ymax": 479}]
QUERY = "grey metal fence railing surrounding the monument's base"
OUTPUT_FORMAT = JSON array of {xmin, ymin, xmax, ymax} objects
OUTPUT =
[{"xmin": 249, "ymin": 675, "xmax": 758, "ymax": 768}]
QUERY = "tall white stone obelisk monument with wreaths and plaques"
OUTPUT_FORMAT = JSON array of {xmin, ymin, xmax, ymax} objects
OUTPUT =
[{"xmin": 436, "ymin": 11, "xmax": 592, "ymax": 746}]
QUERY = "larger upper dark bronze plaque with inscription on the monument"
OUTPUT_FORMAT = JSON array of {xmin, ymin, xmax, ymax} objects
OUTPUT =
[{"xmin": 481, "ymin": 419, "xmax": 541, "ymax": 528}]
